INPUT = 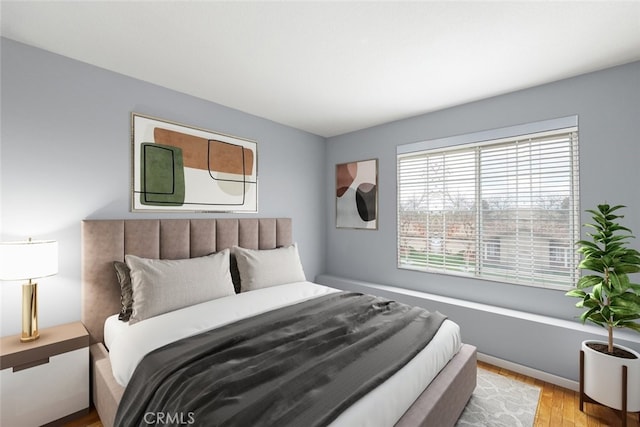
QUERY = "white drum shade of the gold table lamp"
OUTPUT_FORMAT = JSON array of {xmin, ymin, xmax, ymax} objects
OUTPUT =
[{"xmin": 0, "ymin": 240, "xmax": 58, "ymax": 280}]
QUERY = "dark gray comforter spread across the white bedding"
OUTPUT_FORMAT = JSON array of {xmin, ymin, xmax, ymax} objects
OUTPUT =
[{"xmin": 115, "ymin": 292, "xmax": 445, "ymax": 427}]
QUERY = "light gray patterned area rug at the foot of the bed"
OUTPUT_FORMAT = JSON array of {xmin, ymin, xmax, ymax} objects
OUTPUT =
[{"xmin": 456, "ymin": 368, "xmax": 540, "ymax": 427}]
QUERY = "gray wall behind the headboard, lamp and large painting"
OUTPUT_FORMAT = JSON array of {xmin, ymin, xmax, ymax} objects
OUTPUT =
[{"xmin": 0, "ymin": 38, "xmax": 326, "ymax": 335}]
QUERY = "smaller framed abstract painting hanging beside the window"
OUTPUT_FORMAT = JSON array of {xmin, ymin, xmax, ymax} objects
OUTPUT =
[{"xmin": 336, "ymin": 159, "xmax": 378, "ymax": 230}]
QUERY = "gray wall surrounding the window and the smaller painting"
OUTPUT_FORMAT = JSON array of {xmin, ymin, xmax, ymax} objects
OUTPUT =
[{"xmin": 325, "ymin": 62, "xmax": 640, "ymax": 378}]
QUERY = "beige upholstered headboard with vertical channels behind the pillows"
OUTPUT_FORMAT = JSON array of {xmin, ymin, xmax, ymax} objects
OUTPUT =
[{"xmin": 81, "ymin": 218, "xmax": 293, "ymax": 344}]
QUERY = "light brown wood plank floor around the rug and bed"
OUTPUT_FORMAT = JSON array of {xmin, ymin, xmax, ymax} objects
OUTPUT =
[{"xmin": 65, "ymin": 362, "xmax": 640, "ymax": 427}]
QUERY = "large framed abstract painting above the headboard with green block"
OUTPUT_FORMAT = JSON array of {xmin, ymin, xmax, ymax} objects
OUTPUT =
[{"xmin": 131, "ymin": 113, "xmax": 258, "ymax": 212}]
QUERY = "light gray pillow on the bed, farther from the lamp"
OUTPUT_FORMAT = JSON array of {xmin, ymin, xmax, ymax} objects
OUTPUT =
[{"xmin": 233, "ymin": 244, "xmax": 306, "ymax": 292}]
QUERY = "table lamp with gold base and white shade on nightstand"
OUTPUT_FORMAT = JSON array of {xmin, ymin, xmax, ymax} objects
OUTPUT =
[{"xmin": 0, "ymin": 239, "xmax": 58, "ymax": 342}]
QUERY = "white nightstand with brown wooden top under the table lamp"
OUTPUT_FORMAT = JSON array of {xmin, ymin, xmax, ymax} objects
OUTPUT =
[{"xmin": 0, "ymin": 322, "xmax": 89, "ymax": 427}]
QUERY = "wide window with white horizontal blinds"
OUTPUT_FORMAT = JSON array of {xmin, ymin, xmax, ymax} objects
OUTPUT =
[{"xmin": 397, "ymin": 117, "xmax": 580, "ymax": 289}]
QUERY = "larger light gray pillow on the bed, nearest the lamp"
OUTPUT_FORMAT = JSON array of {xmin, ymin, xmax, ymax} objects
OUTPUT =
[{"xmin": 125, "ymin": 249, "xmax": 235, "ymax": 323}]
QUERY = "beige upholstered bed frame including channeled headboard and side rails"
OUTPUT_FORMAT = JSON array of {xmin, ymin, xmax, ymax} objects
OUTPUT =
[{"xmin": 82, "ymin": 218, "xmax": 476, "ymax": 427}]
